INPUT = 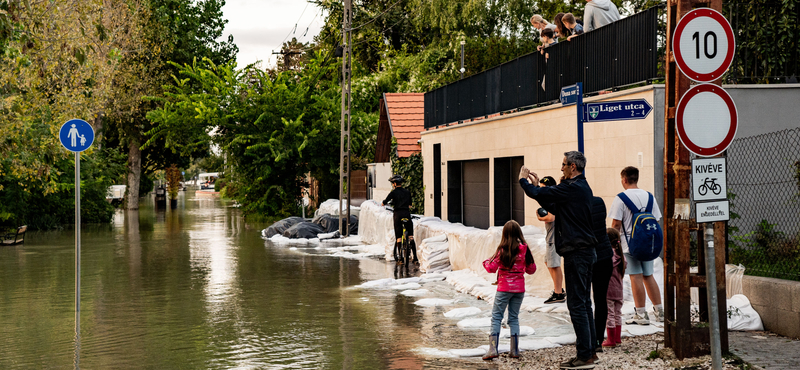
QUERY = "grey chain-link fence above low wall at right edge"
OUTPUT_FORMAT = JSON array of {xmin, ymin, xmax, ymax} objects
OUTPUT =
[{"xmin": 727, "ymin": 128, "xmax": 800, "ymax": 280}]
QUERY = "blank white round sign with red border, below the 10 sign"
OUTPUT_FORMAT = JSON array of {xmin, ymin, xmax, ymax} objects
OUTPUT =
[{"xmin": 675, "ymin": 84, "xmax": 739, "ymax": 157}]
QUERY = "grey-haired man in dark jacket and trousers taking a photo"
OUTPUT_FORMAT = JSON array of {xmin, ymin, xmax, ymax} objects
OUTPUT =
[{"xmin": 519, "ymin": 151, "xmax": 597, "ymax": 369}]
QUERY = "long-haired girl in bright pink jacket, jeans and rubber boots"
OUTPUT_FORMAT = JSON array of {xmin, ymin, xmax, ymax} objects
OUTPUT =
[{"xmin": 483, "ymin": 220, "xmax": 536, "ymax": 360}]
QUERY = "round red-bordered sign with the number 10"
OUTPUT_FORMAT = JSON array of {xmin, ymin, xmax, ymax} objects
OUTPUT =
[{"xmin": 672, "ymin": 8, "xmax": 736, "ymax": 82}]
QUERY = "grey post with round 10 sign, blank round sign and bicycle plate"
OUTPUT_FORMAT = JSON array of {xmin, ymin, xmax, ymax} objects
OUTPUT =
[{"xmin": 671, "ymin": 8, "xmax": 738, "ymax": 370}]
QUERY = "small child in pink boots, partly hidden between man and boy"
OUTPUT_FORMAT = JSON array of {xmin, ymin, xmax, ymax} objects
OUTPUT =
[{"xmin": 598, "ymin": 228, "xmax": 626, "ymax": 347}]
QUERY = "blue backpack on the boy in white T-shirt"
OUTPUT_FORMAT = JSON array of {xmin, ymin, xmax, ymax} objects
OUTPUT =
[{"xmin": 617, "ymin": 192, "xmax": 664, "ymax": 261}]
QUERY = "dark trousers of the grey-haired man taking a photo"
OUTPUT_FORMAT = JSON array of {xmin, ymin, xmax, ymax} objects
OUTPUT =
[{"xmin": 564, "ymin": 248, "xmax": 597, "ymax": 360}]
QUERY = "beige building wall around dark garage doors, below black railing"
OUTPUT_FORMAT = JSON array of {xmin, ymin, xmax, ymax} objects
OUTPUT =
[{"xmin": 422, "ymin": 85, "xmax": 664, "ymax": 226}]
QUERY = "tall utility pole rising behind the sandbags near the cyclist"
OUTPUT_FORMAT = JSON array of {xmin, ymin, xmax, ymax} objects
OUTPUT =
[{"xmin": 339, "ymin": 0, "xmax": 353, "ymax": 236}]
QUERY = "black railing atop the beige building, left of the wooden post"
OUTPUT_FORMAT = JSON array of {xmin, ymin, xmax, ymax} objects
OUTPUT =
[{"xmin": 425, "ymin": 7, "xmax": 659, "ymax": 129}]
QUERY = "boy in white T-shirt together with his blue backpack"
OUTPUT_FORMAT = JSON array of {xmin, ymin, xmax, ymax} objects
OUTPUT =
[{"xmin": 608, "ymin": 166, "xmax": 664, "ymax": 325}]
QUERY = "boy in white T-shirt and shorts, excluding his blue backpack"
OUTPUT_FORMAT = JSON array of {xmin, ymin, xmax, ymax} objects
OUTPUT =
[{"xmin": 608, "ymin": 166, "xmax": 664, "ymax": 325}]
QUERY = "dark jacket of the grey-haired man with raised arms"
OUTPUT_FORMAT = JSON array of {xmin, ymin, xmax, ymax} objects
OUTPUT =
[{"xmin": 519, "ymin": 174, "xmax": 597, "ymax": 256}]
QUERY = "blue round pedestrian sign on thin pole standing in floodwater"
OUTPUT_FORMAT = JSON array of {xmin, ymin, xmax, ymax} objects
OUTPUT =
[{"xmin": 58, "ymin": 119, "xmax": 94, "ymax": 368}]
